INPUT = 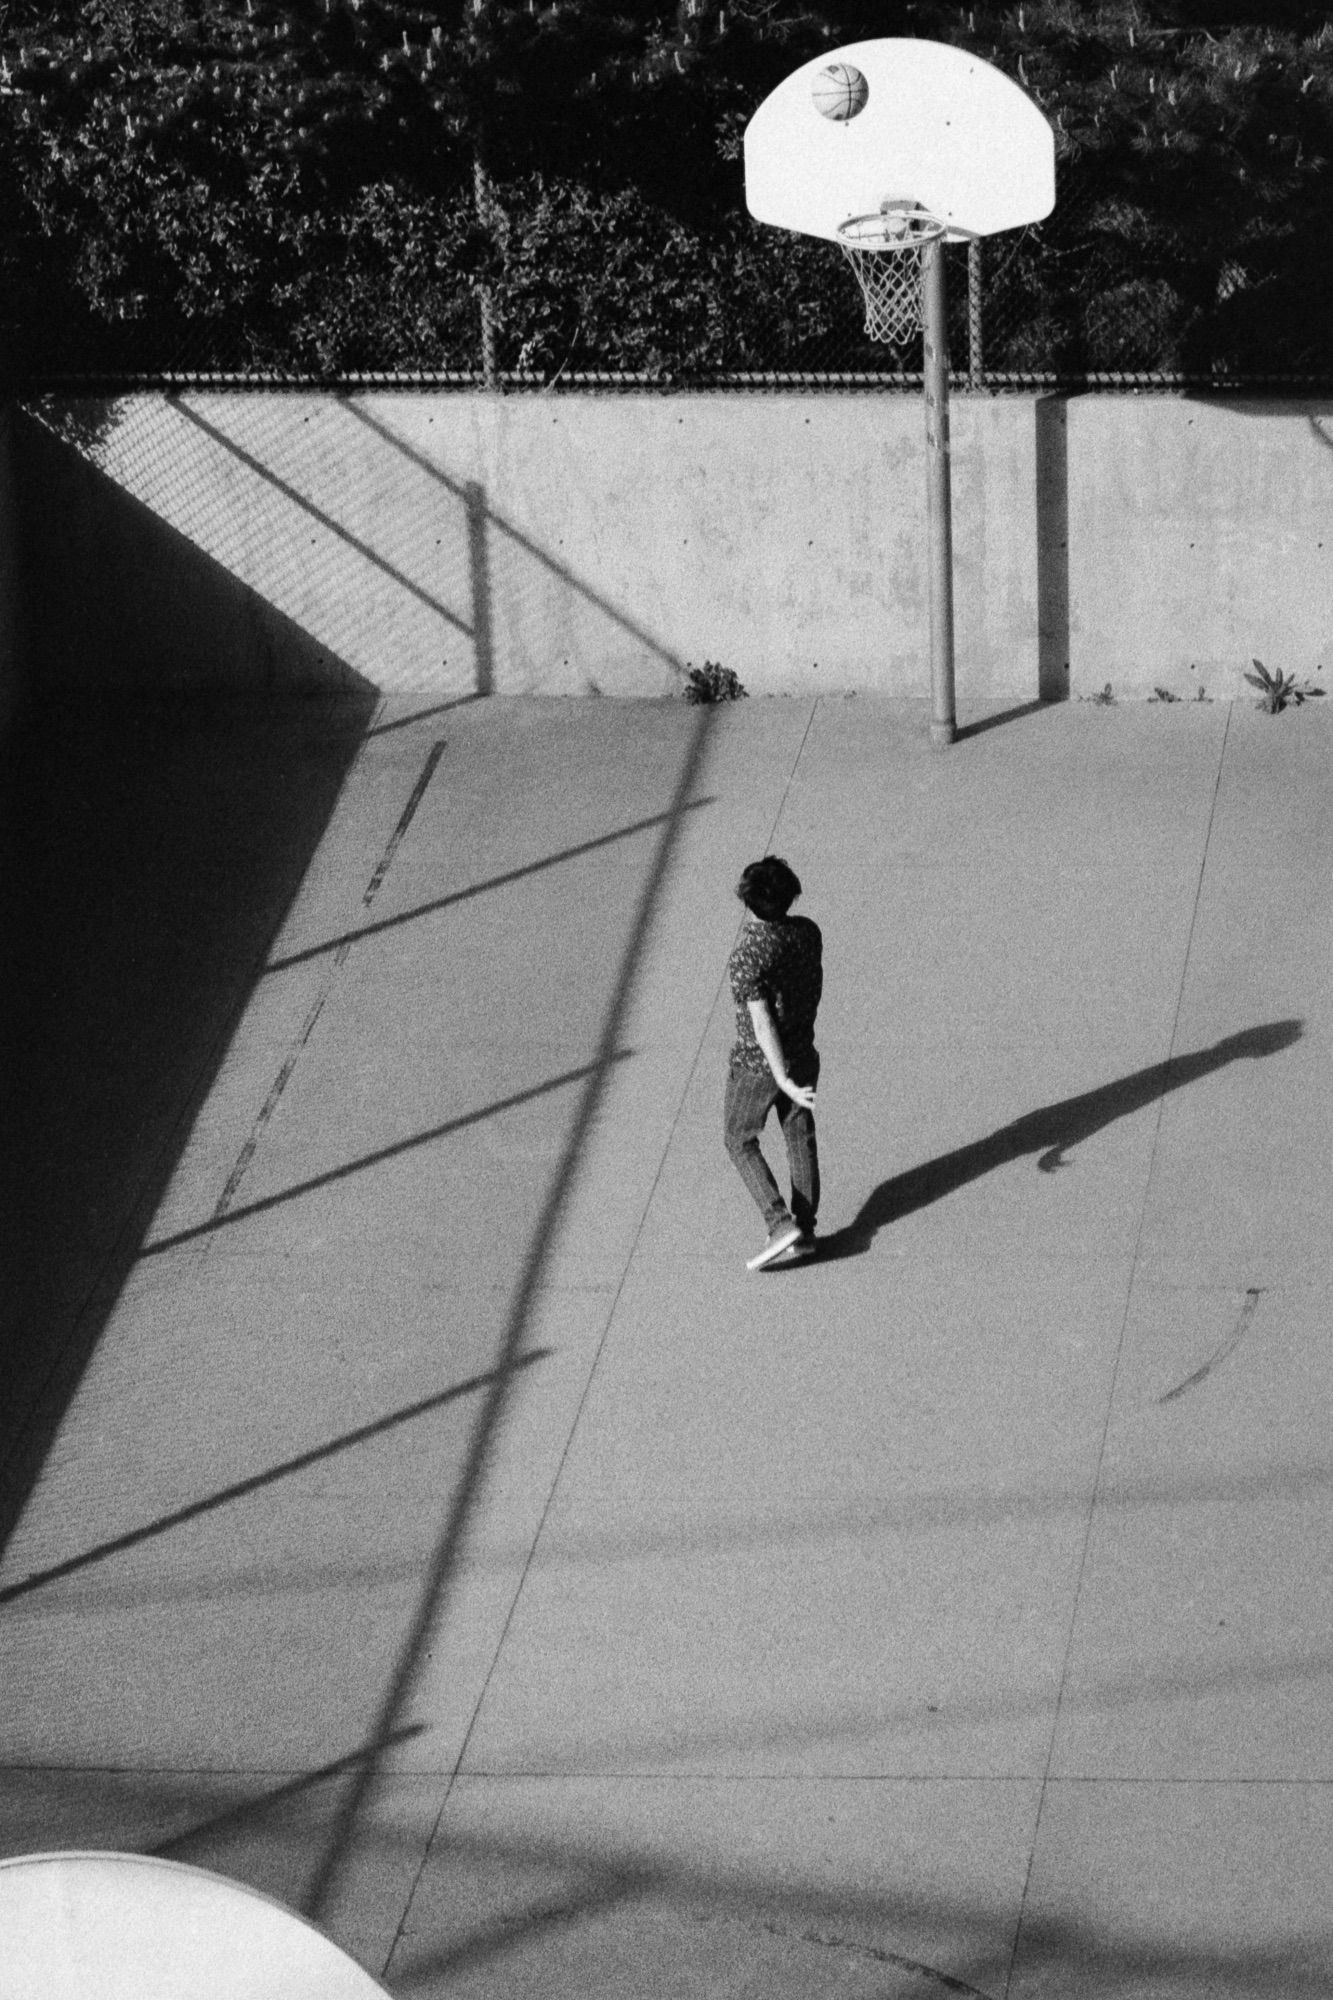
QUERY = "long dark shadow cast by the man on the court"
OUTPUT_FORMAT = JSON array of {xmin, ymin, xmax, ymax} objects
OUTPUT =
[{"xmin": 819, "ymin": 1020, "xmax": 1303, "ymax": 1264}]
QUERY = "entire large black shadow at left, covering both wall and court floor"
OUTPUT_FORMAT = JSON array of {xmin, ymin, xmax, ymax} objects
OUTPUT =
[{"xmin": 0, "ymin": 410, "xmax": 376, "ymax": 1546}]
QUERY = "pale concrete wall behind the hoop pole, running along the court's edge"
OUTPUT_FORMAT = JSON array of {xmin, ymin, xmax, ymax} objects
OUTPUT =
[{"xmin": 18, "ymin": 392, "xmax": 1333, "ymax": 706}]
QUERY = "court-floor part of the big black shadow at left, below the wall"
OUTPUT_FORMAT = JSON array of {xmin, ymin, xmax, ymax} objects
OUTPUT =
[{"xmin": 0, "ymin": 698, "xmax": 370, "ymax": 1538}]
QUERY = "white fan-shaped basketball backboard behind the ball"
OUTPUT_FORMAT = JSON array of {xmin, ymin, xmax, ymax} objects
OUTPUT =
[{"xmin": 745, "ymin": 38, "xmax": 1055, "ymax": 242}]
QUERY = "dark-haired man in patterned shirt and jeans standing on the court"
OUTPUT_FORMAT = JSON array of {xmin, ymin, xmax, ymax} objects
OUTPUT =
[{"xmin": 725, "ymin": 854, "xmax": 825, "ymax": 1270}]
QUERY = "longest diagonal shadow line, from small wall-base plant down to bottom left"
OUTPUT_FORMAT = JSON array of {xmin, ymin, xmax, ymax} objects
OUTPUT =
[{"xmin": 302, "ymin": 706, "xmax": 713, "ymax": 1922}]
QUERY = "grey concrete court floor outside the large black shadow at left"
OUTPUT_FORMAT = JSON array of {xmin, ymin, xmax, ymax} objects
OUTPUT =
[{"xmin": 0, "ymin": 698, "xmax": 1333, "ymax": 2000}]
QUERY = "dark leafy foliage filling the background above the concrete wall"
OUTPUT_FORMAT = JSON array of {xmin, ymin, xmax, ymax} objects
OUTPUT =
[{"xmin": 0, "ymin": 0, "xmax": 1333, "ymax": 376}]
